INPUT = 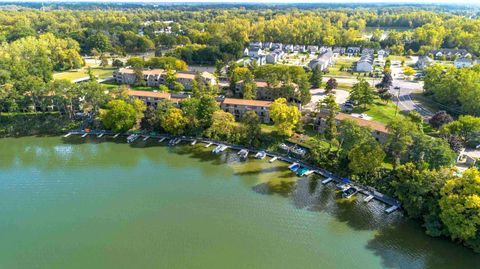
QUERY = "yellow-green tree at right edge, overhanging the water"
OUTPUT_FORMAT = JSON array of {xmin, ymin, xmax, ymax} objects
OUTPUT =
[{"xmin": 439, "ymin": 168, "xmax": 480, "ymax": 241}]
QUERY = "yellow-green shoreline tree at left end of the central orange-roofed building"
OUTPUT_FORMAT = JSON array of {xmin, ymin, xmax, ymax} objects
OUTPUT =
[{"xmin": 205, "ymin": 110, "xmax": 236, "ymax": 142}]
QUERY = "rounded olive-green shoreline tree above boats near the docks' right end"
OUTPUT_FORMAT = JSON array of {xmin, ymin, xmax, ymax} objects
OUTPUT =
[{"xmin": 348, "ymin": 140, "xmax": 385, "ymax": 180}]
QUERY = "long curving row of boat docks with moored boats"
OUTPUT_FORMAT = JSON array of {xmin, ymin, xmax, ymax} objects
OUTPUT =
[{"xmin": 64, "ymin": 130, "xmax": 401, "ymax": 214}]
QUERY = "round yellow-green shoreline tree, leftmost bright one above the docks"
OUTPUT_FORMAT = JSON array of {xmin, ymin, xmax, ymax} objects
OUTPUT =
[{"xmin": 100, "ymin": 100, "xmax": 137, "ymax": 132}]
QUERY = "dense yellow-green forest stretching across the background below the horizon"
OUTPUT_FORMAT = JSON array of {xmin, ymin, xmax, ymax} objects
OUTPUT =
[{"xmin": 0, "ymin": 6, "xmax": 480, "ymax": 64}]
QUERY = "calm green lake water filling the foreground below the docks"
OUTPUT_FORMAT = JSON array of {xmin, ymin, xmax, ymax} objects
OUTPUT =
[{"xmin": 0, "ymin": 137, "xmax": 480, "ymax": 269}]
